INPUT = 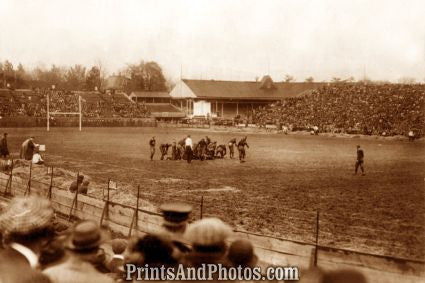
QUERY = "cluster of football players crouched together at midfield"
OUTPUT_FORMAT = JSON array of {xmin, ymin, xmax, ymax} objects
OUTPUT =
[{"xmin": 149, "ymin": 135, "xmax": 249, "ymax": 163}]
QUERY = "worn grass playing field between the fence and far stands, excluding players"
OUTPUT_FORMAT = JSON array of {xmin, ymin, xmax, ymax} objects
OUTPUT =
[{"xmin": 3, "ymin": 128, "xmax": 425, "ymax": 259}]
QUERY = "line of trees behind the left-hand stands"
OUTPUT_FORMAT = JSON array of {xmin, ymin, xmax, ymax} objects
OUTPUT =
[{"xmin": 0, "ymin": 60, "xmax": 170, "ymax": 92}]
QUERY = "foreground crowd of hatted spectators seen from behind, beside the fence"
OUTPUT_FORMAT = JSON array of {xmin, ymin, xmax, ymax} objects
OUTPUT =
[{"xmin": 0, "ymin": 195, "xmax": 366, "ymax": 283}]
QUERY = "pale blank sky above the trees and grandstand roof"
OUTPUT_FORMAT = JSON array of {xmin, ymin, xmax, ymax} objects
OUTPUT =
[{"xmin": 0, "ymin": 0, "xmax": 425, "ymax": 82}]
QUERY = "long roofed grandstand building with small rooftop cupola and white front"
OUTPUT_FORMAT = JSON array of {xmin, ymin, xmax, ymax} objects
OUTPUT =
[{"xmin": 170, "ymin": 76, "xmax": 325, "ymax": 119}]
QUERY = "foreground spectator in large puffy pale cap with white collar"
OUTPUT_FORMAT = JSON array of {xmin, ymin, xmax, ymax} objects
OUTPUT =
[{"xmin": 0, "ymin": 196, "xmax": 54, "ymax": 282}]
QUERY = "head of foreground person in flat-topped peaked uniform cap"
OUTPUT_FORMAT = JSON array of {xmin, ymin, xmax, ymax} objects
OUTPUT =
[{"xmin": 160, "ymin": 202, "xmax": 192, "ymax": 256}]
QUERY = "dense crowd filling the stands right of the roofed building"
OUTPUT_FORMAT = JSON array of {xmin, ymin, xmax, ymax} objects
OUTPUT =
[{"xmin": 252, "ymin": 84, "xmax": 425, "ymax": 137}]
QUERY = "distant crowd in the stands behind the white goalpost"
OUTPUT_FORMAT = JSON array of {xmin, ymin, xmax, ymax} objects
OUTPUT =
[{"xmin": 0, "ymin": 89, "xmax": 150, "ymax": 118}]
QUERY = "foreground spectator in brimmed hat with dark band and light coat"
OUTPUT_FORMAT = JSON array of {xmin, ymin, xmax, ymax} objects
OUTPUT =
[{"xmin": 43, "ymin": 220, "xmax": 114, "ymax": 283}]
